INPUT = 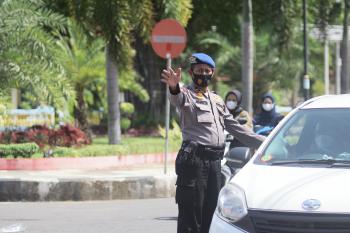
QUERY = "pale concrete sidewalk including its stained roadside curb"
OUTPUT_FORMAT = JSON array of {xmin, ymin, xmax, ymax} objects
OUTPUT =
[{"xmin": 0, "ymin": 165, "xmax": 176, "ymax": 201}]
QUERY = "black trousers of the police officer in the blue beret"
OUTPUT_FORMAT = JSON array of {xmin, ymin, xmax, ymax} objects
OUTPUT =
[{"xmin": 176, "ymin": 158, "xmax": 221, "ymax": 233}]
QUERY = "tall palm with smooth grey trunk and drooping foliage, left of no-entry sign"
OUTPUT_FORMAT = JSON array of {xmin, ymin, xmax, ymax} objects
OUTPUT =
[{"xmin": 67, "ymin": 0, "xmax": 153, "ymax": 144}]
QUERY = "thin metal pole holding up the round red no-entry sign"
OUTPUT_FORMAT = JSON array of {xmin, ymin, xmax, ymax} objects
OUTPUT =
[{"xmin": 164, "ymin": 53, "xmax": 171, "ymax": 174}]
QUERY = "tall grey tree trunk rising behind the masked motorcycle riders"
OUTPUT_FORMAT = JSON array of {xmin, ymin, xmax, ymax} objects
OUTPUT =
[{"xmin": 242, "ymin": 0, "xmax": 254, "ymax": 113}]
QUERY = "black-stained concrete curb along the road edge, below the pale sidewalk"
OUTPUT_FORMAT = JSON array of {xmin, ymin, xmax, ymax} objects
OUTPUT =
[{"xmin": 0, "ymin": 175, "xmax": 176, "ymax": 201}]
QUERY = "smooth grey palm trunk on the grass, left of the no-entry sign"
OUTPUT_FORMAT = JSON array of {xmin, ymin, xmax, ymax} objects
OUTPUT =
[{"xmin": 106, "ymin": 39, "xmax": 121, "ymax": 144}]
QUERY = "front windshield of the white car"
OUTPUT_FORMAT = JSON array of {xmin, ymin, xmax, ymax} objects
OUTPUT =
[{"xmin": 254, "ymin": 109, "xmax": 350, "ymax": 167}]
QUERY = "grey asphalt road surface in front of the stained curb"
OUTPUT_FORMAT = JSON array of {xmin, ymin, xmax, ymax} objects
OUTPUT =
[{"xmin": 0, "ymin": 198, "xmax": 177, "ymax": 233}]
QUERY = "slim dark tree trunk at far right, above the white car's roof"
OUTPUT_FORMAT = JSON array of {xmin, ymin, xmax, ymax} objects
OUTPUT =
[{"xmin": 341, "ymin": 0, "xmax": 350, "ymax": 94}]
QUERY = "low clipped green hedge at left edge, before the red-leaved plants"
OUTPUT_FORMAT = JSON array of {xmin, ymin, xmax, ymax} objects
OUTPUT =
[{"xmin": 0, "ymin": 143, "xmax": 40, "ymax": 158}]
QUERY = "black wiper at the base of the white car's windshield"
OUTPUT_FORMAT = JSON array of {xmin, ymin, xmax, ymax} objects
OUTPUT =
[{"xmin": 270, "ymin": 159, "xmax": 350, "ymax": 167}]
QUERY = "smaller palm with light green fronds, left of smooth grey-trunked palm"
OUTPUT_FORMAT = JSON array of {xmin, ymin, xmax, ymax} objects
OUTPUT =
[{"xmin": 56, "ymin": 20, "xmax": 105, "ymax": 138}]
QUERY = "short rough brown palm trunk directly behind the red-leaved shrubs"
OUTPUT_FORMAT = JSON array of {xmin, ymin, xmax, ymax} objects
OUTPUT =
[{"xmin": 74, "ymin": 85, "xmax": 92, "ymax": 141}]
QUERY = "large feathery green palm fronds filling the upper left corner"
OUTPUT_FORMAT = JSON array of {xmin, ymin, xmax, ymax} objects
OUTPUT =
[{"xmin": 0, "ymin": 0, "xmax": 72, "ymax": 106}]
